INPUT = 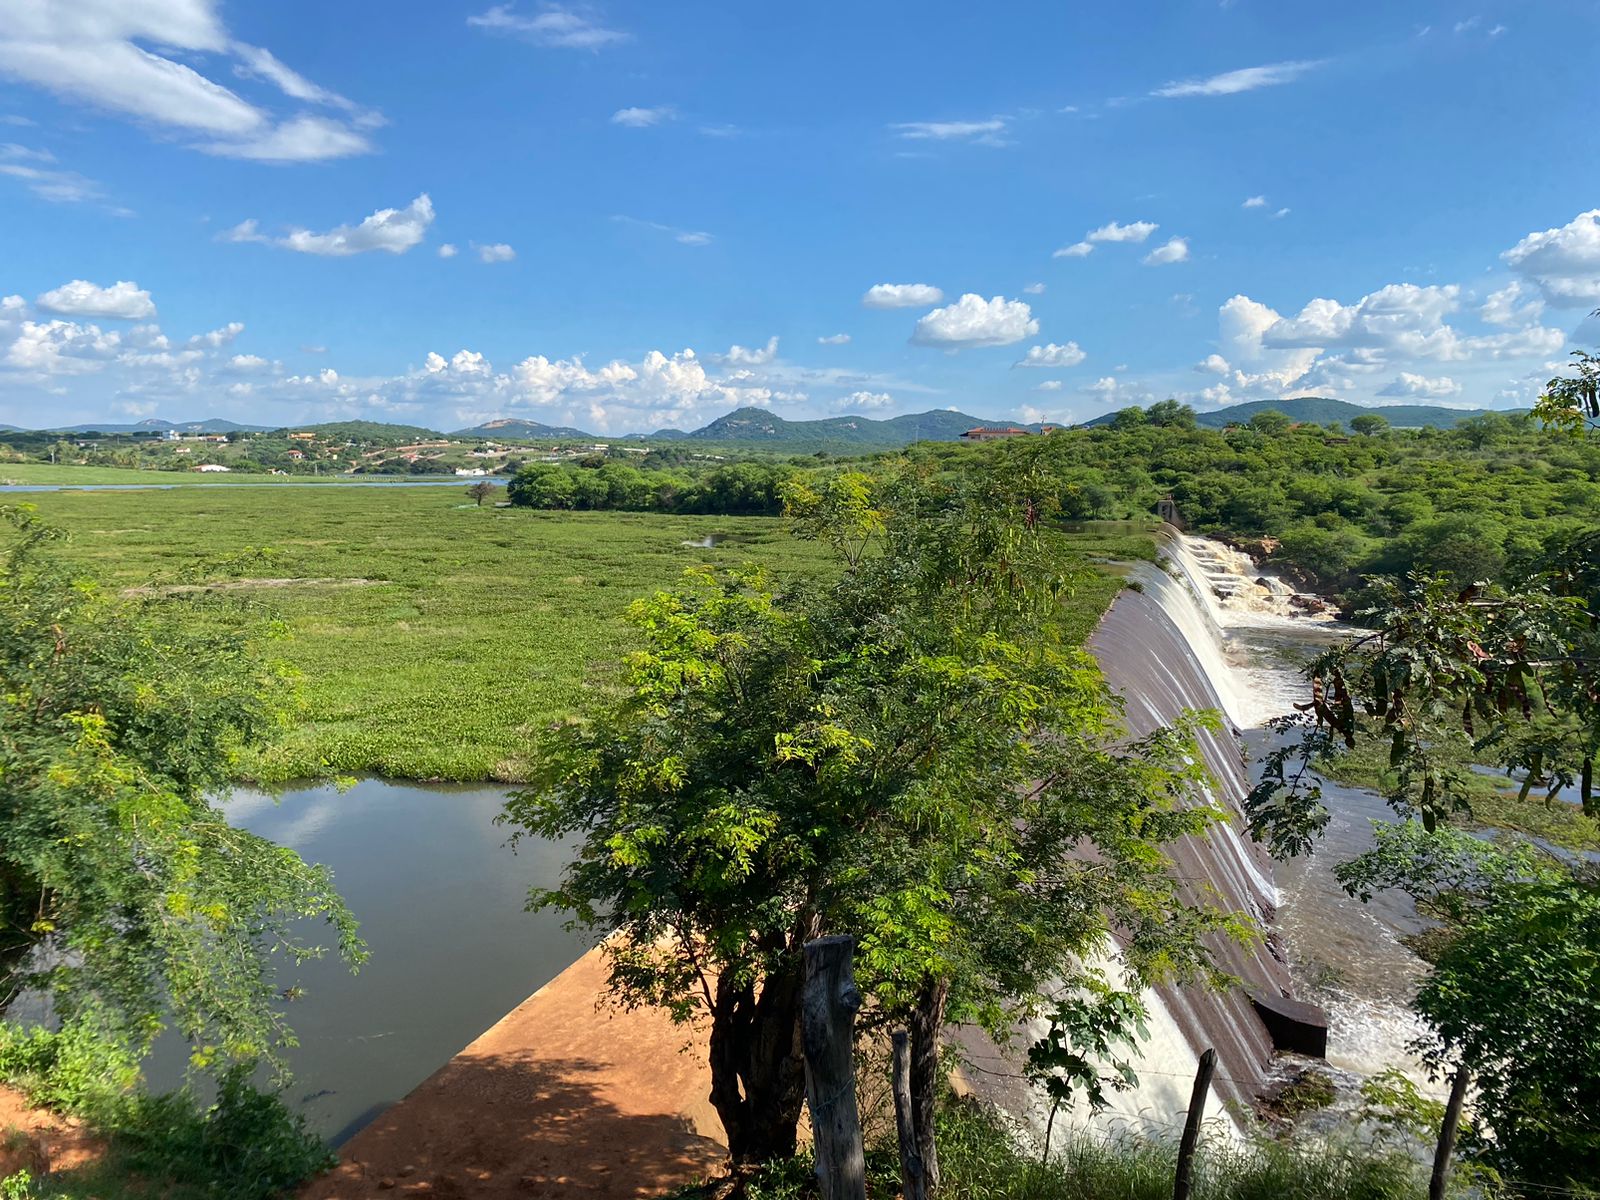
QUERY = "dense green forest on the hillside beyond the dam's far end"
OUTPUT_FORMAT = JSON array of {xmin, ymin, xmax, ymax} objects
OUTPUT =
[{"xmin": 930, "ymin": 403, "xmax": 1600, "ymax": 590}]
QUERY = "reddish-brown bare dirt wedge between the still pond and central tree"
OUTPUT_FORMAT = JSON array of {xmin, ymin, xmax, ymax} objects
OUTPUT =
[{"xmin": 301, "ymin": 950, "xmax": 726, "ymax": 1200}]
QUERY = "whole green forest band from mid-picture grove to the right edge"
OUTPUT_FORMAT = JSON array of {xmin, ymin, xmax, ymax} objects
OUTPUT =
[{"xmin": 510, "ymin": 402, "xmax": 1600, "ymax": 592}]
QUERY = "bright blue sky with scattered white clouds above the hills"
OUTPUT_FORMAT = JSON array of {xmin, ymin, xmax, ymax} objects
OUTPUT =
[{"xmin": 0, "ymin": 0, "xmax": 1600, "ymax": 434}]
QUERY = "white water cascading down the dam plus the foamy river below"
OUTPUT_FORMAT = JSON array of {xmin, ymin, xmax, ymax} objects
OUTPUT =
[{"xmin": 974, "ymin": 530, "xmax": 1419, "ymax": 1134}]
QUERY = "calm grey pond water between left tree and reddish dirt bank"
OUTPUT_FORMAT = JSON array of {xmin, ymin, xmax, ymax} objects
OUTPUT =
[{"xmin": 149, "ymin": 779, "xmax": 589, "ymax": 1142}]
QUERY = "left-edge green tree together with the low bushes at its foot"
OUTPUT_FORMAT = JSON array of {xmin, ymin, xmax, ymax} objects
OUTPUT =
[{"xmin": 0, "ymin": 507, "xmax": 365, "ymax": 1200}]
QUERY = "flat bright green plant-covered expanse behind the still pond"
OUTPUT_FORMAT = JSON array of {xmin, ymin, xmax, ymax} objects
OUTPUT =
[{"xmin": 25, "ymin": 483, "xmax": 1152, "ymax": 781}]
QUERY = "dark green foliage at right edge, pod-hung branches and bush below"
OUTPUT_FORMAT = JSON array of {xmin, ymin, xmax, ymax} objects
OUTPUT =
[{"xmin": 1246, "ymin": 547, "xmax": 1600, "ymax": 1184}]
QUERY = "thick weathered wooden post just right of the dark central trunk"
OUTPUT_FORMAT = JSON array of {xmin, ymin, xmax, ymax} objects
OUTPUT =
[{"xmin": 800, "ymin": 938, "xmax": 867, "ymax": 1200}]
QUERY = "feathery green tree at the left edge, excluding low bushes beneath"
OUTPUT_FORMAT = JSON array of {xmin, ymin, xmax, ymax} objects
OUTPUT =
[{"xmin": 0, "ymin": 507, "xmax": 363, "ymax": 1064}]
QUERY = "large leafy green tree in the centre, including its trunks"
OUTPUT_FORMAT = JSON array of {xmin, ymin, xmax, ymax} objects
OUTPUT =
[{"xmin": 507, "ymin": 470, "xmax": 1240, "ymax": 1173}]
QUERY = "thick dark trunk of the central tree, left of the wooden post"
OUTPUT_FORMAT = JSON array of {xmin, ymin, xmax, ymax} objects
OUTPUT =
[{"xmin": 710, "ymin": 966, "xmax": 805, "ymax": 1166}]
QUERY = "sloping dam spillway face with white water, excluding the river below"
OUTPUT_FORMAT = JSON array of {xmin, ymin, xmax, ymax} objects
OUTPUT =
[{"xmin": 987, "ymin": 528, "xmax": 1339, "ymax": 1136}]
